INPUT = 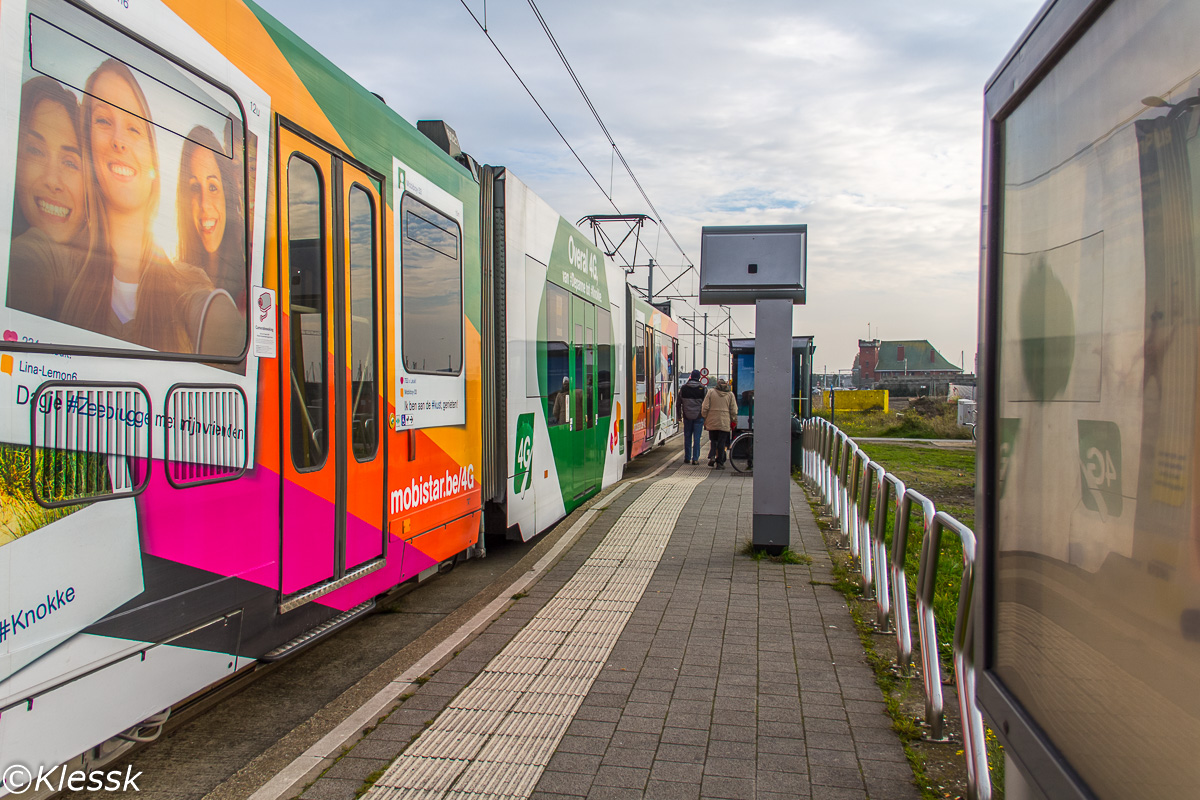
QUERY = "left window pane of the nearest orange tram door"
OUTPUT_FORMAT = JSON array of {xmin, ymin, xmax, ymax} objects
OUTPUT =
[{"xmin": 288, "ymin": 155, "xmax": 329, "ymax": 470}]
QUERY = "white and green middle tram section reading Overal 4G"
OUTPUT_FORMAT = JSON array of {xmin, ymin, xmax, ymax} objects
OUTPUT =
[{"xmin": 482, "ymin": 167, "xmax": 628, "ymax": 540}]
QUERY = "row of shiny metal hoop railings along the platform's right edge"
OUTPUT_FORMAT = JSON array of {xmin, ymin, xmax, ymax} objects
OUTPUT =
[{"xmin": 803, "ymin": 417, "xmax": 991, "ymax": 800}]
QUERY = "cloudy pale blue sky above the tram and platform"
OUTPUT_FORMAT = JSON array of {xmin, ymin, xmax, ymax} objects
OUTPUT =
[{"xmin": 250, "ymin": 0, "xmax": 1042, "ymax": 373}]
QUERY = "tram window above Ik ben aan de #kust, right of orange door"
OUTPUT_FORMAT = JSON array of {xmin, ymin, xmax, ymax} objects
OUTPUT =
[{"xmin": 400, "ymin": 196, "xmax": 462, "ymax": 375}]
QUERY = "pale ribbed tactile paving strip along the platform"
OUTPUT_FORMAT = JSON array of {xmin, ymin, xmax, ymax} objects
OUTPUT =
[{"xmin": 366, "ymin": 473, "xmax": 707, "ymax": 800}]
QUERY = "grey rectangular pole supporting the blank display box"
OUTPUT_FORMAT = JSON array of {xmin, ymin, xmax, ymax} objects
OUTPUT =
[{"xmin": 751, "ymin": 300, "xmax": 792, "ymax": 555}]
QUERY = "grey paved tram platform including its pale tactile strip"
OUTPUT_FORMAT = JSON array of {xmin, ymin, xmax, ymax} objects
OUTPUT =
[{"xmin": 280, "ymin": 439, "xmax": 919, "ymax": 800}]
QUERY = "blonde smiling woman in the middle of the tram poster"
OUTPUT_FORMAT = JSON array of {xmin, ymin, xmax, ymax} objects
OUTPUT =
[{"xmin": 62, "ymin": 59, "xmax": 244, "ymax": 355}]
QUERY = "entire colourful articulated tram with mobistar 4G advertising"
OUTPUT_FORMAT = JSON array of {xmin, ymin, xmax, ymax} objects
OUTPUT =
[{"xmin": 0, "ymin": 0, "xmax": 676, "ymax": 782}]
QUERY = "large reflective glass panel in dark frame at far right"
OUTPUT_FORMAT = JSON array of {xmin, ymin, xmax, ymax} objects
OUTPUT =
[{"xmin": 994, "ymin": 0, "xmax": 1200, "ymax": 800}]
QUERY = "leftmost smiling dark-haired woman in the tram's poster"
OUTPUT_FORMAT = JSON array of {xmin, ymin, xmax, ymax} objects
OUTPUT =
[{"xmin": 7, "ymin": 76, "xmax": 88, "ymax": 318}]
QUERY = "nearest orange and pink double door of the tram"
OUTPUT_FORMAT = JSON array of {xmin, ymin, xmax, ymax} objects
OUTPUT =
[{"xmin": 277, "ymin": 128, "xmax": 384, "ymax": 596}]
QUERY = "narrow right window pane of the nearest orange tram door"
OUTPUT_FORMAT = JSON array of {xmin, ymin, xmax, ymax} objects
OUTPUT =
[{"xmin": 349, "ymin": 186, "xmax": 379, "ymax": 461}]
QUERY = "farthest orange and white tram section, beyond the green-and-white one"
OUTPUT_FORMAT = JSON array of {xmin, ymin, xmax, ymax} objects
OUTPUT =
[{"xmin": 626, "ymin": 289, "xmax": 679, "ymax": 458}]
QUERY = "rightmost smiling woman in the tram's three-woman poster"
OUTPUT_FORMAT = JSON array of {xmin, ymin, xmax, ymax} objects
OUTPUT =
[{"xmin": 175, "ymin": 125, "xmax": 246, "ymax": 308}]
